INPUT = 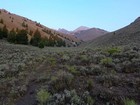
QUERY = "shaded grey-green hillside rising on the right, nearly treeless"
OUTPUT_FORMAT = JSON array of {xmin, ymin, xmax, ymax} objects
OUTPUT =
[{"xmin": 89, "ymin": 17, "xmax": 140, "ymax": 47}]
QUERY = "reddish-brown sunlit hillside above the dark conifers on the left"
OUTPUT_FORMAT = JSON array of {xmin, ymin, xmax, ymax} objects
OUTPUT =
[{"xmin": 0, "ymin": 9, "xmax": 79, "ymax": 45}]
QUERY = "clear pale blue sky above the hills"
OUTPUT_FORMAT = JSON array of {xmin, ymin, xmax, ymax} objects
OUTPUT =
[{"xmin": 0, "ymin": 0, "xmax": 140, "ymax": 31}]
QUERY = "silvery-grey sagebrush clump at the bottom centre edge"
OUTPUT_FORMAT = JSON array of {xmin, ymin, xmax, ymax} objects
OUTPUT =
[{"xmin": 46, "ymin": 89, "xmax": 95, "ymax": 105}]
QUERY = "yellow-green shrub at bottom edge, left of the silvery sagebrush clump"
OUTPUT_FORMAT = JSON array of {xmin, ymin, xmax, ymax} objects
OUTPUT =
[{"xmin": 37, "ymin": 89, "xmax": 51, "ymax": 105}]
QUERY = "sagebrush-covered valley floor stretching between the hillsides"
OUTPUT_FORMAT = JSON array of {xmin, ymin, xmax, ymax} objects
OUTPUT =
[{"xmin": 0, "ymin": 41, "xmax": 140, "ymax": 105}]
